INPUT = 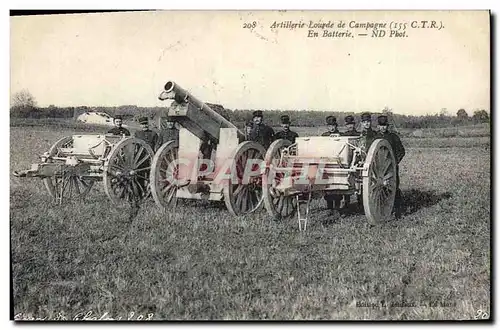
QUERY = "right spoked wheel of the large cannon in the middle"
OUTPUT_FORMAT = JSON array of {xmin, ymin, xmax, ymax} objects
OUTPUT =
[{"xmin": 223, "ymin": 141, "xmax": 266, "ymax": 216}]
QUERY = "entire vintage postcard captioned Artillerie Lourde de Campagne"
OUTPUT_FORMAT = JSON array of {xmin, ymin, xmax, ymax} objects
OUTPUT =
[{"xmin": 10, "ymin": 10, "xmax": 492, "ymax": 321}]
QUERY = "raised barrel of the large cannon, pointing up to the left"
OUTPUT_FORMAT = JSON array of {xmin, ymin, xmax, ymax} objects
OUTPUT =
[{"xmin": 158, "ymin": 81, "xmax": 245, "ymax": 140}]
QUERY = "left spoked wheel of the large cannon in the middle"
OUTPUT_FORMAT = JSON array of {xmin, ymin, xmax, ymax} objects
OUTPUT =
[{"xmin": 150, "ymin": 141, "xmax": 179, "ymax": 208}]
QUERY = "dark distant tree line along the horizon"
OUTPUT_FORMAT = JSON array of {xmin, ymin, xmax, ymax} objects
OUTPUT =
[{"xmin": 10, "ymin": 91, "xmax": 490, "ymax": 129}]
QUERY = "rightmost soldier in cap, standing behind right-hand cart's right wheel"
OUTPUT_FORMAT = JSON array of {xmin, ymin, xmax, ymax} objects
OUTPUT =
[{"xmin": 377, "ymin": 115, "xmax": 406, "ymax": 219}]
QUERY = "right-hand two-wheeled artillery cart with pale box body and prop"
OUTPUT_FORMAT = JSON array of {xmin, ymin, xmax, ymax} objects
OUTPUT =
[{"xmin": 262, "ymin": 135, "xmax": 396, "ymax": 230}]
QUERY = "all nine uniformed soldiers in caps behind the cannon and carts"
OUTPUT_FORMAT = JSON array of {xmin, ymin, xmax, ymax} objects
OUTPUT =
[{"xmin": 108, "ymin": 110, "xmax": 405, "ymax": 218}]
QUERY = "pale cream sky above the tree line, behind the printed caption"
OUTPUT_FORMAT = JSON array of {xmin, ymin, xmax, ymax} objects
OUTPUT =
[{"xmin": 11, "ymin": 11, "xmax": 490, "ymax": 115}]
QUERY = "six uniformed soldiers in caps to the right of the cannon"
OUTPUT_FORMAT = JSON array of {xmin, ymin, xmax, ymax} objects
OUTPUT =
[{"xmin": 246, "ymin": 111, "xmax": 406, "ymax": 219}]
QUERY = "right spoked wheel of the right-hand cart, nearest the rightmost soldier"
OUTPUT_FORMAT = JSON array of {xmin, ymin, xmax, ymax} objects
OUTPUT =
[{"xmin": 363, "ymin": 139, "xmax": 396, "ymax": 225}]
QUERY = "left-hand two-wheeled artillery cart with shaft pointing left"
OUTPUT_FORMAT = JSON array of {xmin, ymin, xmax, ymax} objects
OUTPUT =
[{"xmin": 13, "ymin": 134, "xmax": 153, "ymax": 204}]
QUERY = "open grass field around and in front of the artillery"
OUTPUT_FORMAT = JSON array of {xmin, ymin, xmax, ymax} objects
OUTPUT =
[{"xmin": 10, "ymin": 127, "xmax": 491, "ymax": 320}]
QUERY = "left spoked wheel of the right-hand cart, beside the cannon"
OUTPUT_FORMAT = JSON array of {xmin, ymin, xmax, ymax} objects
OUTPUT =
[{"xmin": 262, "ymin": 139, "xmax": 297, "ymax": 219}]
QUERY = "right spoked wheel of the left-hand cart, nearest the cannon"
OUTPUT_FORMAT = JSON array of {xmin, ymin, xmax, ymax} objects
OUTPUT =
[{"xmin": 103, "ymin": 137, "xmax": 153, "ymax": 204}]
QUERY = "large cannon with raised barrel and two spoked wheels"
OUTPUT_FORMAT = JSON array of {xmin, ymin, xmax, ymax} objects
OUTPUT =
[{"xmin": 150, "ymin": 81, "xmax": 266, "ymax": 215}]
